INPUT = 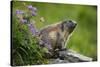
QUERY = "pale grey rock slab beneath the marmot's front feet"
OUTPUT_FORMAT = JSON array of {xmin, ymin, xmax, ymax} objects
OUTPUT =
[{"xmin": 50, "ymin": 50, "xmax": 92, "ymax": 64}]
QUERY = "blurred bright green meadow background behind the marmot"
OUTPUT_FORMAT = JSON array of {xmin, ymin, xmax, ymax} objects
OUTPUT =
[{"xmin": 13, "ymin": 1, "xmax": 97, "ymax": 64}]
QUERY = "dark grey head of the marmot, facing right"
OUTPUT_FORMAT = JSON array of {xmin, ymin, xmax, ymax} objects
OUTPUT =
[{"xmin": 61, "ymin": 20, "xmax": 77, "ymax": 34}]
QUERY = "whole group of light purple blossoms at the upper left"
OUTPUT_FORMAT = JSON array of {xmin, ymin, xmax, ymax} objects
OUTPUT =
[{"xmin": 16, "ymin": 5, "xmax": 37, "ymax": 35}]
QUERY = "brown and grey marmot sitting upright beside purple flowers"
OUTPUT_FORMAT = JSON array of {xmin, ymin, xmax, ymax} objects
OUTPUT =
[{"xmin": 39, "ymin": 20, "xmax": 77, "ymax": 56}]
